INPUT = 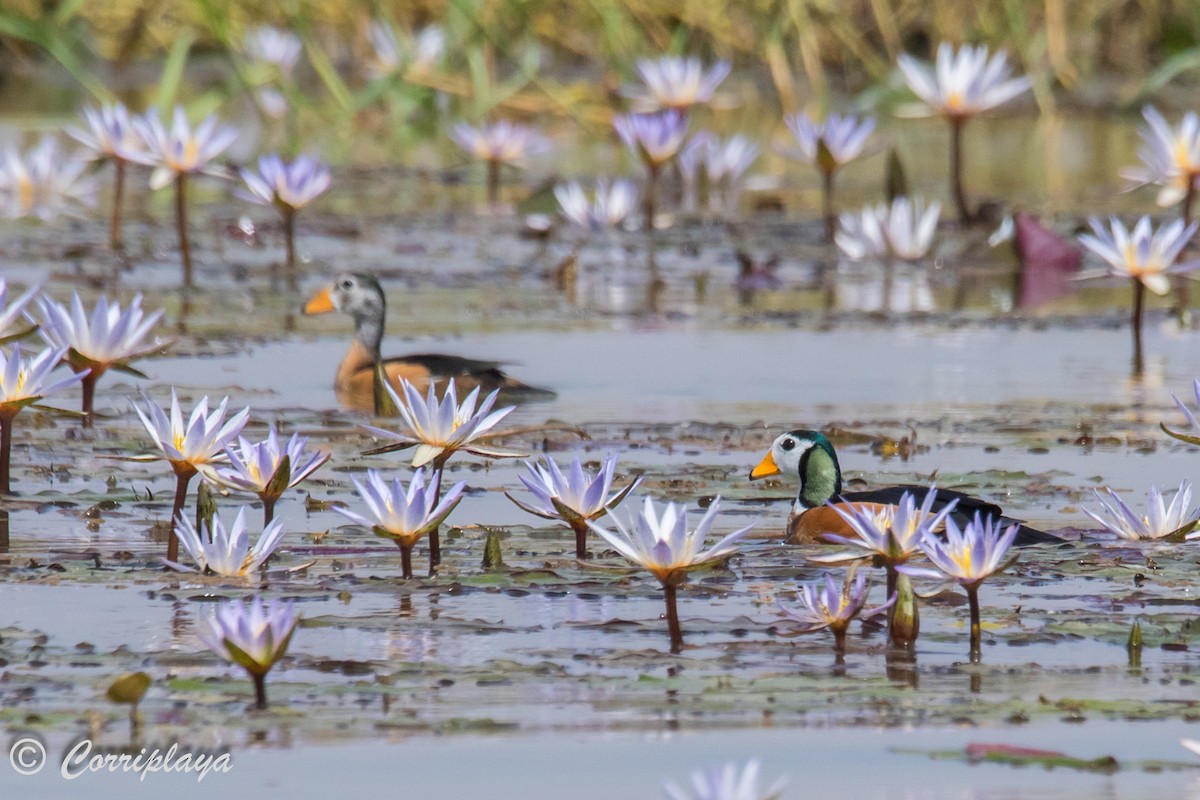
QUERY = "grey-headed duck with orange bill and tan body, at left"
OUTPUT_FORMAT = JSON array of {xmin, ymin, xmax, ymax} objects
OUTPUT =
[{"xmin": 302, "ymin": 272, "xmax": 554, "ymax": 411}]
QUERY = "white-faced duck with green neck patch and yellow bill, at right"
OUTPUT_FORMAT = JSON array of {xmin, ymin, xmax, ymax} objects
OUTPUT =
[{"xmin": 750, "ymin": 428, "xmax": 1060, "ymax": 545}]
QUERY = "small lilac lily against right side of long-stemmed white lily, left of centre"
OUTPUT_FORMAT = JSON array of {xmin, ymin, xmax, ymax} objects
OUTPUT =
[{"xmin": 208, "ymin": 425, "xmax": 330, "ymax": 525}]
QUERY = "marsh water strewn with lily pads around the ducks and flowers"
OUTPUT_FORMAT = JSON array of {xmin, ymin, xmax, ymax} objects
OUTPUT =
[{"xmin": 0, "ymin": 107, "xmax": 1200, "ymax": 798}]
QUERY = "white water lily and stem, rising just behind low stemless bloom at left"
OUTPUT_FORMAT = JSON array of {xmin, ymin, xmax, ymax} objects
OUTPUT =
[{"xmin": 133, "ymin": 387, "xmax": 250, "ymax": 561}]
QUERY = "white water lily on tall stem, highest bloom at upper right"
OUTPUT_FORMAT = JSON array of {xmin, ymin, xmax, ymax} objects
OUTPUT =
[{"xmin": 899, "ymin": 42, "xmax": 1033, "ymax": 222}]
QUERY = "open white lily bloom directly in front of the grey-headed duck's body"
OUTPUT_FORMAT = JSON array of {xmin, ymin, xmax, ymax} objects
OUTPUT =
[{"xmin": 364, "ymin": 378, "xmax": 523, "ymax": 467}]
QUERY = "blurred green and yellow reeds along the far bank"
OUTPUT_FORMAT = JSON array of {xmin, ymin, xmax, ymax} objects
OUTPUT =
[{"xmin": 0, "ymin": 0, "xmax": 1200, "ymax": 160}]
